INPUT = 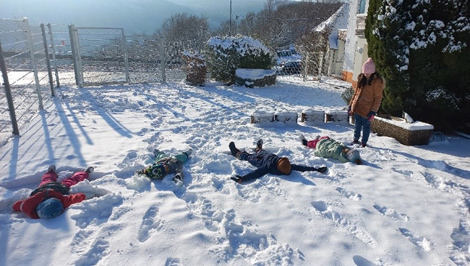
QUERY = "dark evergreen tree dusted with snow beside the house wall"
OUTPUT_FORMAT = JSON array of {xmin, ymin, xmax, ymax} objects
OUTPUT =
[{"xmin": 366, "ymin": 0, "xmax": 470, "ymax": 130}]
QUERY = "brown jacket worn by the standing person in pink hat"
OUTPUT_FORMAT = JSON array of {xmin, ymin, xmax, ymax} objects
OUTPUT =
[{"xmin": 349, "ymin": 74, "xmax": 385, "ymax": 118}]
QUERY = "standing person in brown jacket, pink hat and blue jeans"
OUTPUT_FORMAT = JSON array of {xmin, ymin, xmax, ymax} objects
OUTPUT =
[{"xmin": 348, "ymin": 58, "xmax": 385, "ymax": 147}]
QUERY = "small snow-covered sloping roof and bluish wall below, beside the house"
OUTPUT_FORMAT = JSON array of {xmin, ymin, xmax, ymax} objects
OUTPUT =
[{"xmin": 313, "ymin": 4, "xmax": 349, "ymax": 49}]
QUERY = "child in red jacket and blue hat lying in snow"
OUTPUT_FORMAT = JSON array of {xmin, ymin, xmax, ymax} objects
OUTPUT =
[{"xmin": 12, "ymin": 165, "xmax": 94, "ymax": 219}]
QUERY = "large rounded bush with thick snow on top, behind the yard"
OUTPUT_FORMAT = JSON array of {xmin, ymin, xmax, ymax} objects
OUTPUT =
[{"xmin": 206, "ymin": 35, "xmax": 274, "ymax": 84}]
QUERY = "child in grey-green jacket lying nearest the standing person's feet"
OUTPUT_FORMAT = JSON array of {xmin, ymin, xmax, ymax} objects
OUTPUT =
[{"xmin": 300, "ymin": 135, "xmax": 362, "ymax": 164}]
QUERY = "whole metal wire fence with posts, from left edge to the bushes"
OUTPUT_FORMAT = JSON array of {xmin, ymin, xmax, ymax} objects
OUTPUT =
[{"xmin": 0, "ymin": 19, "xmax": 203, "ymax": 146}]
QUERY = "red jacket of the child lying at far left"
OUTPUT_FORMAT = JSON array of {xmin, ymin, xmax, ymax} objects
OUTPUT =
[{"xmin": 12, "ymin": 189, "xmax": 86, "ymax": 219}]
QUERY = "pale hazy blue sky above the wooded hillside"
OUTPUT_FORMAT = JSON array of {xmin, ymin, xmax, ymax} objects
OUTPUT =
[{"xmin": 0, "ymin": 0, "xmax": 265, "ymax": 34}]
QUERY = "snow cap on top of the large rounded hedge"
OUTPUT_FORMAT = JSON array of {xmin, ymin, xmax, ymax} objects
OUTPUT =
[{"xmin": 207, "ymin": 36, "xmax": 271, "ymax": 56}]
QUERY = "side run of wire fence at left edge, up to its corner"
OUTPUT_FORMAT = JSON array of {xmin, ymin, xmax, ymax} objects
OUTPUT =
[{"xmin": 0, "ymin": 19, "xmax": 53, "ymax": 141}]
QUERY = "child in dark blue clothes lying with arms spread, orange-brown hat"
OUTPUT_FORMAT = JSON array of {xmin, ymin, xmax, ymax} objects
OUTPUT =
[{"xmin": 229, "ymin": 139, "xmax": 327, "ymax": 183}]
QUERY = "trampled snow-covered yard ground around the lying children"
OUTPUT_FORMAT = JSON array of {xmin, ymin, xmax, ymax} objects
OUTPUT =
[{"xmin": 0, "ymin": 77, "xmax": 470, "ymax": 265}]
